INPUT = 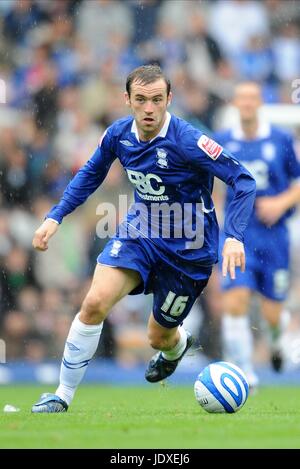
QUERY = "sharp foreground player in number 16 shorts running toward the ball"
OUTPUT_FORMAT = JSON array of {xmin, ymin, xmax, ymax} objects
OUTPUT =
[{"xmin": 32, "ymin": 65, "xmax": 255, "ymax": 413}]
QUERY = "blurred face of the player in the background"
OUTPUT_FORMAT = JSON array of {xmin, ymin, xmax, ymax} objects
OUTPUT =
[{"xmin": 233, "ymin": 83, "xmax": 262, "ymax": 121}]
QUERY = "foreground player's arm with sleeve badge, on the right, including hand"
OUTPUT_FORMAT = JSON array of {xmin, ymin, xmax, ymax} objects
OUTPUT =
[{"xmin": 183, "ymin": 130, "xmax": 256, "ymax": 279}]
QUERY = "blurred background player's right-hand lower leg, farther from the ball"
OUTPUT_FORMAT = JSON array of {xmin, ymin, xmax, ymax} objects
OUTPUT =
[{"xmin": 261, "ymin": 297, "xmax": 289, "ymax": 371}]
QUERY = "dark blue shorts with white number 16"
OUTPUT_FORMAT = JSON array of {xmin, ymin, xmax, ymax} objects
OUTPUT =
[{"xmin": 97, "ymin": 238, "xmax": 211, "ymax": 328}]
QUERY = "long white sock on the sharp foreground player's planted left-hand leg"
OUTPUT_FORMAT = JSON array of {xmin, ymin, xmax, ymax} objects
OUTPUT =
[{"xmin": 55, "ymin": 313, "xmax": 103, "ymax": 405}]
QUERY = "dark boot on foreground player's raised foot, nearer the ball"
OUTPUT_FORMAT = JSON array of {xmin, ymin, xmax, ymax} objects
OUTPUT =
[{"xmin": 145, "ymin": 332, "xmax": 194, "ymax": 383}]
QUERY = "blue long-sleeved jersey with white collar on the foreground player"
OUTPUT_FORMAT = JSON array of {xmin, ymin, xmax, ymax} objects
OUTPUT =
[{"xmin": 47, "ymin": 113, "xmax": 255, "ymax": 266}]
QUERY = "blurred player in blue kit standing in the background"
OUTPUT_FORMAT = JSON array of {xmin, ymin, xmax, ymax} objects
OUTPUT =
[{"xmin": 215, "ymin": 82, "xmax": 300, "ymax": 387}]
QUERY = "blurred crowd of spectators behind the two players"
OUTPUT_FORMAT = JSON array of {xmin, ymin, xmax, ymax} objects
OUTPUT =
[{"xmin": 0, "ymin": 0, "xmax": 300, "ymax": 363}]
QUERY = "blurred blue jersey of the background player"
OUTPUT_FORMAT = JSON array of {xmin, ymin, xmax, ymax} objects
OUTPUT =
[{"xmin": 214, "ymin": 123, "xmax": 300, "ymax": 237}]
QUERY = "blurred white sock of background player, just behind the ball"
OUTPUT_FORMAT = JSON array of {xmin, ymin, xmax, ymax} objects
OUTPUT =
[{"xmin": 222, "ymin": 314, "xmax": 255, "ymax": 377}]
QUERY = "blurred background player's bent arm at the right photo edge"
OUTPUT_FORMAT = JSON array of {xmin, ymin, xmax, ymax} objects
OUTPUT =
[{"xmin": 255, "ymin": 136, "xmax": 300, "ymax": 226}]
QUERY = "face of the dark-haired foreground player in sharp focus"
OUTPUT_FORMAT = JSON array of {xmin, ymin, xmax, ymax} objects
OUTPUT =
[{"xmin": 125, "ymin": 78, "xmax": 172, "ymax": 140}]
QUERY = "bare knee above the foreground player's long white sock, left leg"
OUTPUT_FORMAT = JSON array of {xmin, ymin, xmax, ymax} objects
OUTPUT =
[{"xmin": 80, "ymin": 291, "xmax": 111, "ymax": 324}]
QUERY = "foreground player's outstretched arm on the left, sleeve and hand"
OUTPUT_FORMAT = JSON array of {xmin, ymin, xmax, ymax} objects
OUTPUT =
[{"xmin": 32, "ymin": 128, "xmax": 116, "ymax": 251}]
